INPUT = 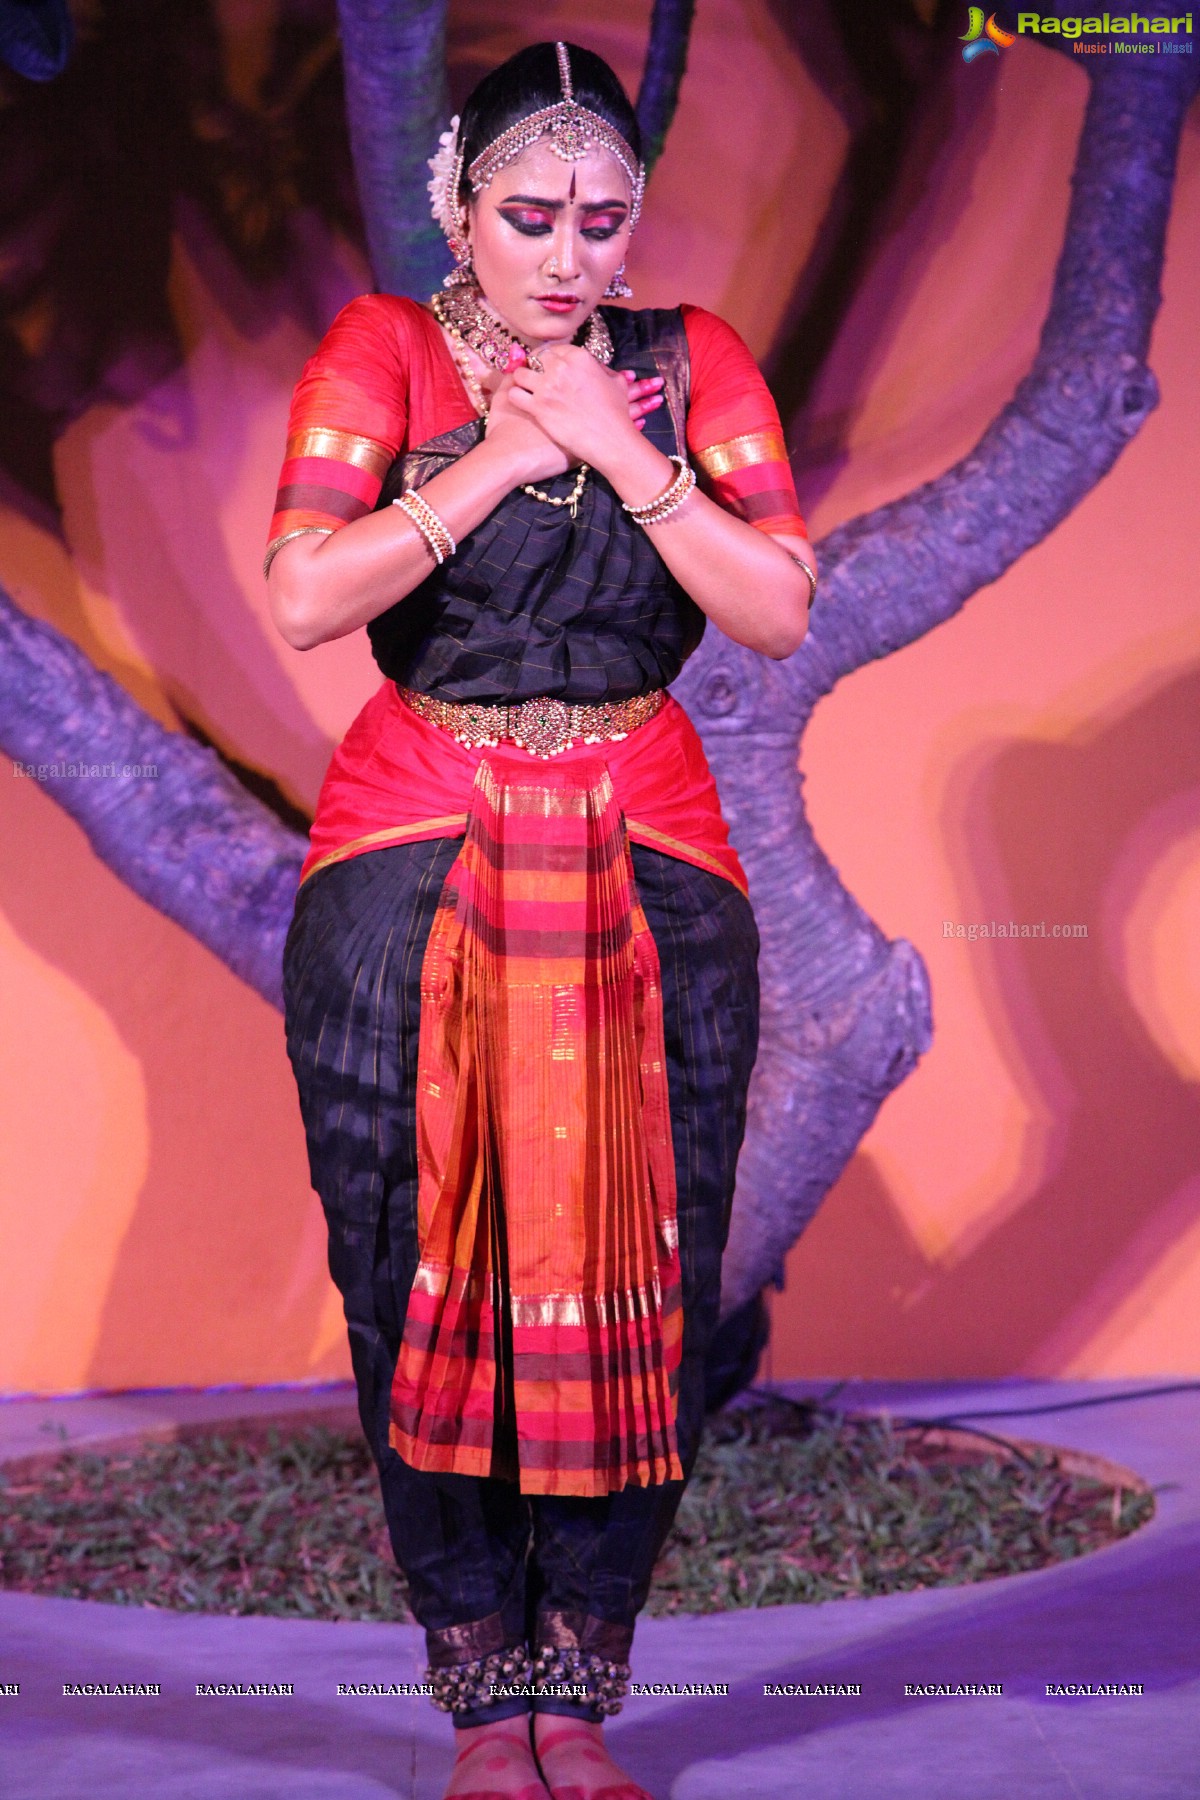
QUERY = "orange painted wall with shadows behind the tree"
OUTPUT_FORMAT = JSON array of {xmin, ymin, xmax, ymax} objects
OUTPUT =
[{"xmin": 0, "ymin": 0, "xmax": 1200, "ymax": 1391}]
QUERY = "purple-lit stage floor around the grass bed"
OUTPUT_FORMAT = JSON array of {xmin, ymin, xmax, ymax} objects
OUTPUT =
[{"xmin": 0, "ymin": 1382, "xmax": 1200, "ymax": 1800}]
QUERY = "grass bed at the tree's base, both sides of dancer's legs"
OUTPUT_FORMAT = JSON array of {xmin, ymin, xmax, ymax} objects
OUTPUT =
[{"xmin": 0, "ymin": 1399, "xmax": 1153, "ymax": 1620}]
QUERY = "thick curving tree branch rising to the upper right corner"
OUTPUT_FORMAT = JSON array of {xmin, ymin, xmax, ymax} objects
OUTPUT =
[{"xmin": 813, "ymin": 56, "xmax": 1196, "ymax": 706}]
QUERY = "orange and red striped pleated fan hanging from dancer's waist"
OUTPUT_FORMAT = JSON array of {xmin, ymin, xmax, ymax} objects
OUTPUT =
[{"xmin": 390, "ymin": 752, "xmax": 682, "ymax": 1496}]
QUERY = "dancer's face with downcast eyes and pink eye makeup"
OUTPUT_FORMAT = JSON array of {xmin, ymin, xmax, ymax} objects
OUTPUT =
[{"xmin": 470, "ymin": 140, "xmax": 631, "ymax": 344}]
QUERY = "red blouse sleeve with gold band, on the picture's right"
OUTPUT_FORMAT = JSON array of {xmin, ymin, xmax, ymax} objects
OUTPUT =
[{"xmin": 682, "ymin": 306, "xmax": 808, "ymax": 536}]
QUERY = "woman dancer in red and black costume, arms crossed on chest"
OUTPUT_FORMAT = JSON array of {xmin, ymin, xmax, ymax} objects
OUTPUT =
[{"xmin": 266, "ymin": 43, "xmax": 817, "ymax": 1800}]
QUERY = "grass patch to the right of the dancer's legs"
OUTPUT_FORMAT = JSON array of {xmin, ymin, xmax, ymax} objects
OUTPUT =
[{"xmin": 648, "ymin": 1400, "xmax": 1153, "ymax": 1613}]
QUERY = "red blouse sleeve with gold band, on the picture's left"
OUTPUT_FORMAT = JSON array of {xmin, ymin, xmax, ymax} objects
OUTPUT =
[{"xmin": 263, "ymin": 293, "xmax": 412, "ymax": 572}]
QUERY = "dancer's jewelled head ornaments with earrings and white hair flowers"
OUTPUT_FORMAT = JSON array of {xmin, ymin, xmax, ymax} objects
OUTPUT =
[{"xmin": 428, "ymin": 43, "xmax": 646, "ymax": 301}]
